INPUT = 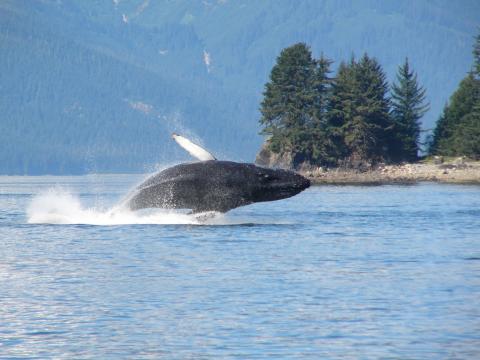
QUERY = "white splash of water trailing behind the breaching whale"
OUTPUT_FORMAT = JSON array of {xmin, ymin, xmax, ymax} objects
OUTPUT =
[{"xmin": 27, "ymin": 188, "xmax": 214, "ymax": 225}]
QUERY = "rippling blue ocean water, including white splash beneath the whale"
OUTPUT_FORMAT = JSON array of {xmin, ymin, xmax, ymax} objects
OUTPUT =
[{"xmin": 0, "ymin": 175, "xmax": 480, "ymax": 359}]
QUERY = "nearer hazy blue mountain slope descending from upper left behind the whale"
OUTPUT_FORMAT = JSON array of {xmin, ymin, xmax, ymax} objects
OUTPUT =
[{"xmin": 0, "ymin": 2, "xmax": 255, "ymax": 174}]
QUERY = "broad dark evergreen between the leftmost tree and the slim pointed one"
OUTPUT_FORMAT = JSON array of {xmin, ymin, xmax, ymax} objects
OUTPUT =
[{"xmin": 330, "ymin": 54, "xmax": 392, "ymax": 166}]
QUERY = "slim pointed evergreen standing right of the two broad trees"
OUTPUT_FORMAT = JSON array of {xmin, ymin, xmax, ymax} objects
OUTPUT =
[{"xmin": 391, "ymin": 58, "xmax": 429, "ymax": 161}]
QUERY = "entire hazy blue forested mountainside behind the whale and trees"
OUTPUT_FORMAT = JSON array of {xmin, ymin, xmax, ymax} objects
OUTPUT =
[{"xmin": 0, "ymin": 0, "xmax": 480, "ymax": 174}]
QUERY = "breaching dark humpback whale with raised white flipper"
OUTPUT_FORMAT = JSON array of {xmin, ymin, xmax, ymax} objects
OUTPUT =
[{"xmin": 127, "ymin": 134, "xmax": 310, "ymax": 213}]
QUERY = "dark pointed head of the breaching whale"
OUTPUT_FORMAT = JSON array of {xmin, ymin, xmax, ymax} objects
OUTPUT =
[{"xmin": 254, "ymin": 167, "xmax": 310, "ymax": 202}]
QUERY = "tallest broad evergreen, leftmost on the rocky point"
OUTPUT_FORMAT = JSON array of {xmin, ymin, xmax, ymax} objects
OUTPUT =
[{"xmin": 260, "ymin": 43, "xmax": 331, "ymax": 166}]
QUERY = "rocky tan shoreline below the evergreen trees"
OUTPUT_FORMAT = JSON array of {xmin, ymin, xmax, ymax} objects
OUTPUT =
[{"xmin": 299, "ymin": 159, "xmax": 480, "ymax": 185}]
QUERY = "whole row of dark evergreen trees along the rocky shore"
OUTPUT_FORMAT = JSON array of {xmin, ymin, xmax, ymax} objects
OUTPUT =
[{"xmin": 260, "ymin": 37, "xmax": 480, "ymax": 168}]
